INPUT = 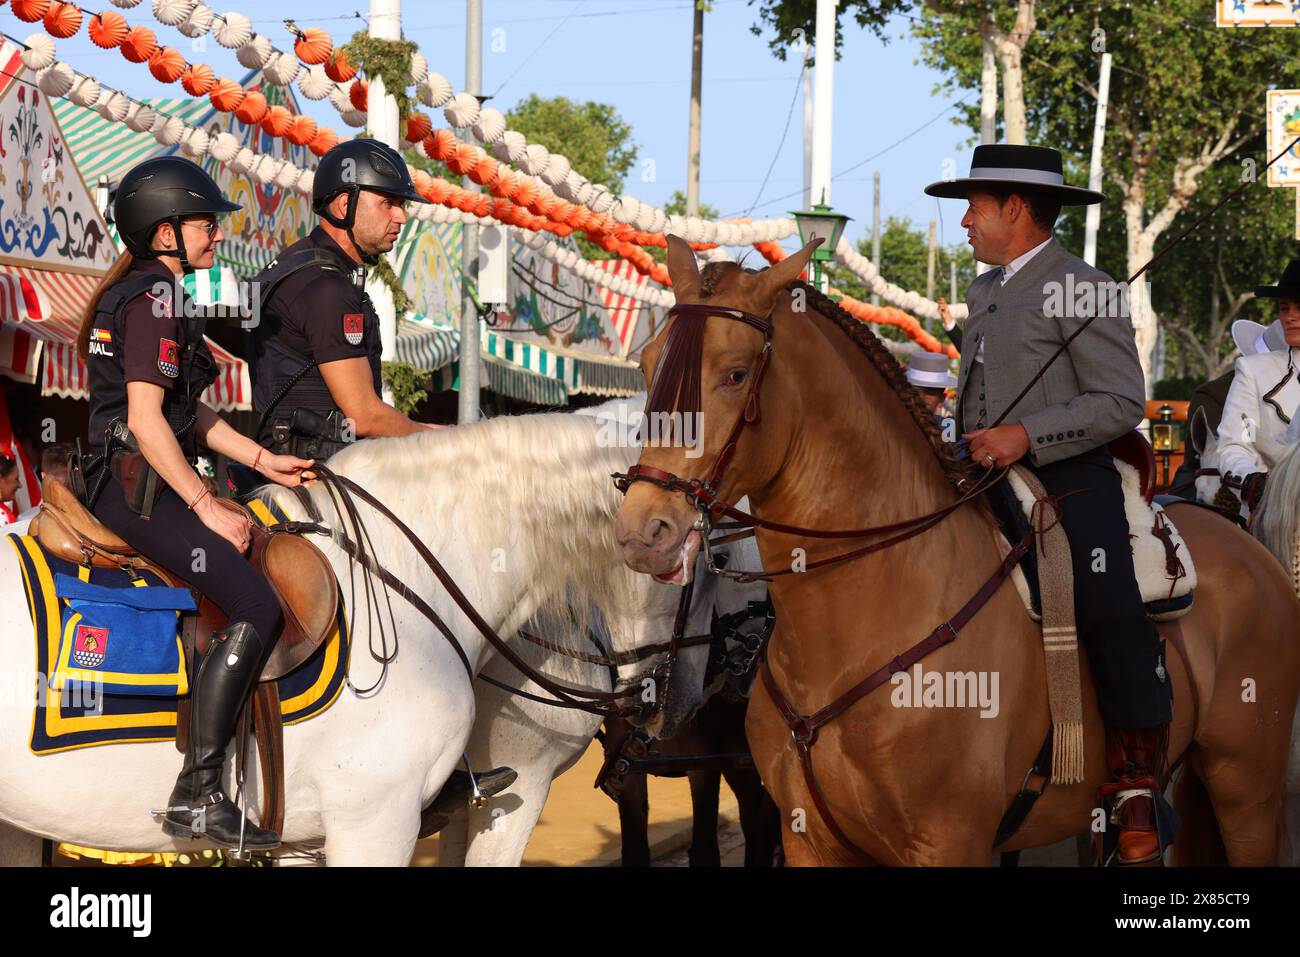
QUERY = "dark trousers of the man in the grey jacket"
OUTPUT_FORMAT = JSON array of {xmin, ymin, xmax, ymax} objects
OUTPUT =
[{"xmin": 1024, "ymin": 449, "xmax": 1174, "ymax": 728}]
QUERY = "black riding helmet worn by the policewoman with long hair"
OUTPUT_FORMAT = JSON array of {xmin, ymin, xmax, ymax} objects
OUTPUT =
[{"xmin": 113, "ymin": 156, "xmax": 243, "ymax": 273}]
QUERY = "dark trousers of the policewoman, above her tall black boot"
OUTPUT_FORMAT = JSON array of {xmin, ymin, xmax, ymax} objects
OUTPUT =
[{"xmin": 95, "ymin": 477, "xmax": 282, "ymax": 653}]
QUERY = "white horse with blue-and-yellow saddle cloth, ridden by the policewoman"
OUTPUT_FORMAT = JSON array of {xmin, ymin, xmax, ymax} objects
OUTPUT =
[{"xmin": 0, "ymin": 415, "xmax": 686, "ymax": 865}]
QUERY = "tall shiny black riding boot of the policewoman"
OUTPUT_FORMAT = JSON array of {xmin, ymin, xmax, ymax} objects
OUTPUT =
[{"xmin": 163, "ymin": 622, "xmax": 280, "ymax": 850}]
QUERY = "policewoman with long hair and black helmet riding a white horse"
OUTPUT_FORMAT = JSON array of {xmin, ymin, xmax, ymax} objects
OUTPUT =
[{"xmin": 78, "ymin": 156, "xmax": 311, "ymax": 850}]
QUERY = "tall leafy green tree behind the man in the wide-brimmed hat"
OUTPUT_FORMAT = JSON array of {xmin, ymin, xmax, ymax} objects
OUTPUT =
[{"xmin": 761, "ymin": 0, "xmax": 1291, "ymax": 392}]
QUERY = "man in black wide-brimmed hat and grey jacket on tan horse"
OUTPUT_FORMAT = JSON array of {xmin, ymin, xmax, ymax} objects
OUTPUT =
[{"xmin": 926, "ymin": 144, "xmax": 1173, "ymax": 865}]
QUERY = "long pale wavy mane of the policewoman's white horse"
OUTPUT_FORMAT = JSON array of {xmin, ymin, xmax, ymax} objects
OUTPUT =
[{"xmin": 266, "ymin": 413, "xmax": 645, "ymax": 639}]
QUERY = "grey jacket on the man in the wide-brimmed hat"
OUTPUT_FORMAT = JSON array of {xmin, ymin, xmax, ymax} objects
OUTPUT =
[{"xmin": 957, "ymin": 239, "xmax": 1145, "ymax": 465}]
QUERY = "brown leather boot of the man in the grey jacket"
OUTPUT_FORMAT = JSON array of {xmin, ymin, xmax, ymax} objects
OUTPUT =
[{"xmin": 1097, "ymin": 724, "xmax": 1169, "ymax": 867}]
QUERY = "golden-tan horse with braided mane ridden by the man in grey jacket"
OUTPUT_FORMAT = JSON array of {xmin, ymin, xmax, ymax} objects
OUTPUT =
[{"xmin": 618, "ymin": 237, "xmax": 1300, "ymax": 865}]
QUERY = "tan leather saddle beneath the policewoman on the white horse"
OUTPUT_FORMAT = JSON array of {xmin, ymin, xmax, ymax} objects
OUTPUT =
[{"xmin": 29, "ymin": 477, "xmax": 338, "ymax": 831}]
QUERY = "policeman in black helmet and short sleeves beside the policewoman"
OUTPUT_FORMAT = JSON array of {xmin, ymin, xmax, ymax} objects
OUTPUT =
[{"xmin": 252, "ymin": 139, "xmax": 429, "ymax": 458}]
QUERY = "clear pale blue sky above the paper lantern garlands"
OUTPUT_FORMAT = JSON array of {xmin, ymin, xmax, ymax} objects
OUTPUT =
[{"xmin": 10, "ymin": 0, "xmax": 970, "ymax": 244}]
